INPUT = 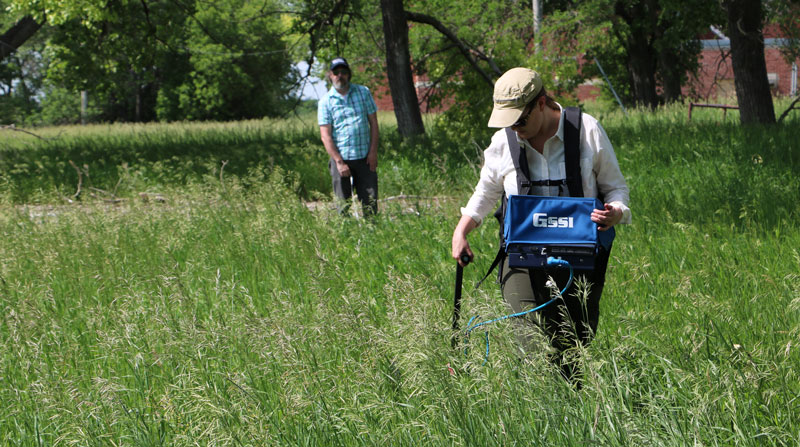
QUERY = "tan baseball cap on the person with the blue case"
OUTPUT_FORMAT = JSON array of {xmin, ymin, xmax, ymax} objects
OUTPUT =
[{"xmin": 489, "ymin": 67, "xmax": 542, "ymax": 127}]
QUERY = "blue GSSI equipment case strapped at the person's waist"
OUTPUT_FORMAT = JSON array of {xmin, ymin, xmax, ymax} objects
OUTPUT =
[{"xmin": 503, "ymin": 195, "xmax": 615, "ymax": 270}]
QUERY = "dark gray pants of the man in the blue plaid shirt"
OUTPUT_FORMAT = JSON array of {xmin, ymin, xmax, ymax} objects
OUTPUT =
[{"xmin": 328, "ymin": 158, "xmax": 378, "ymax": 216}]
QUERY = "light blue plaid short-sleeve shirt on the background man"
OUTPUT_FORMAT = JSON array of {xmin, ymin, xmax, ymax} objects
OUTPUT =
[{"xmin": 317, "ymin": 84, "xmax": 378, "ymax": 160}]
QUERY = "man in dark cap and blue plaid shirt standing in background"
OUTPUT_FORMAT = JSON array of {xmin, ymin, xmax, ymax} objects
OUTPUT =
[{"xmin": 317, "ymin": 57, "xmax": 379, "ymax": 216}]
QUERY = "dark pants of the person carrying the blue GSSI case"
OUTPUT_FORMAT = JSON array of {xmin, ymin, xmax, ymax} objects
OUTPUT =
[{"xmin": 500, "ymin": 250, "xmax": 610, "ymax": 380}]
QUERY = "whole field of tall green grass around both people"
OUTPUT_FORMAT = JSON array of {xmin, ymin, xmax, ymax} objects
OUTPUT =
[{"xmin": 0, "ymin": 107, "xmax": 800, "ymax": 446}]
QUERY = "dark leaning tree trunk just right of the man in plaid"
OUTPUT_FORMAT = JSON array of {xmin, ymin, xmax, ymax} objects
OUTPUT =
[{"xmin": 381, "ymin": 0, "xmax": 425, "ymax": 138}]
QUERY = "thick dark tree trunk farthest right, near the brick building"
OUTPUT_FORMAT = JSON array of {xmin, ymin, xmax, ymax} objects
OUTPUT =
[{"xmin": 723, "ymin": 0, "xmax": 775, "ymax": 124}]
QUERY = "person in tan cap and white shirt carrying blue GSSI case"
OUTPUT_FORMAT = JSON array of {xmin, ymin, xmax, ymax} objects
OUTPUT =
[{"xmin": 452, "ymin": 68, "xmax": 631, "ymax": 384}]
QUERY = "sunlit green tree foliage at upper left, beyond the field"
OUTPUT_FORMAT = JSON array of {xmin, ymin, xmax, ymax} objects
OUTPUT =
[{"xmin": 3, "ymin": 0, "xmax": 296, "ymax": 121}]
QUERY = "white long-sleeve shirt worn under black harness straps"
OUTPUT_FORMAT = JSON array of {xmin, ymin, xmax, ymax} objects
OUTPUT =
[{"xmin": 461, "ymin": 105, "xmax": 631, "ymax": 225}]
